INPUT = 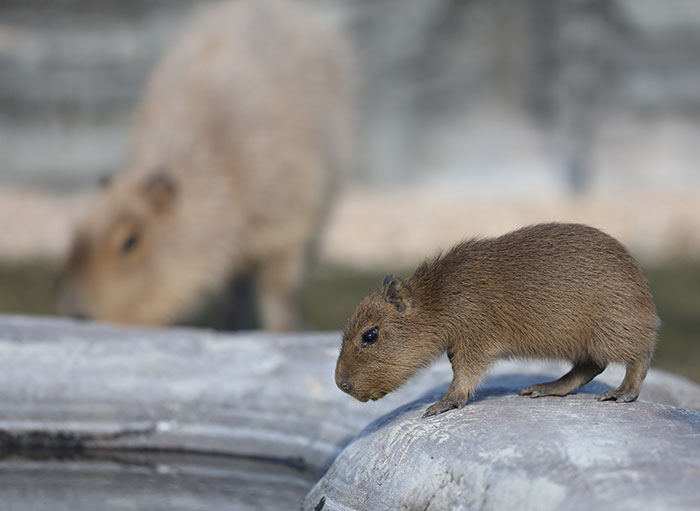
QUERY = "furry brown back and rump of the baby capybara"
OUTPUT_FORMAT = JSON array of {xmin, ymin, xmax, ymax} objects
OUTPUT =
[{"xmin": 440, "ymin": 224, "xmax": 659, "ymax": 363}]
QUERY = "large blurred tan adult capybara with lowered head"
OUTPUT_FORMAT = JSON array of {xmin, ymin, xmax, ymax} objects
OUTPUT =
[{"xmin": 57, "ymin": 0, "xmax": 348, "ymax": 330}]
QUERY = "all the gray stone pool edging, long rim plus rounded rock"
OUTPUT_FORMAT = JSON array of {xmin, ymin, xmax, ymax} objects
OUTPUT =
[{"xmin": 0, "ymin": 315, "xmax": 700, "ymax": 511}]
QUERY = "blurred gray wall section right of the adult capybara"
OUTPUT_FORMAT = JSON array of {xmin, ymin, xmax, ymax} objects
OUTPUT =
[{"xmin": 344, "ymin": 0, "xmax": 700, "ymax": 194}]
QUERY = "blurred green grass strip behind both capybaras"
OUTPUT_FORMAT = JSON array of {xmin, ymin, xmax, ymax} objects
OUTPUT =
[{"xmin": 0, "ymin": 261, "xmax": 700, "ymax": 383}]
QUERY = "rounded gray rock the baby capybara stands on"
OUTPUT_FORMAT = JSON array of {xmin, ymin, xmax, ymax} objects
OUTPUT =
[{"xmin": 303, "ymin": 390, "xmax": 700, "ymax": 511}]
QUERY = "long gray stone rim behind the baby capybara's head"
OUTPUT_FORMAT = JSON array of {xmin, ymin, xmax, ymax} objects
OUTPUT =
[{"xmin": 0, "ymin": 316, "xmax": 449, "ymax": 474}]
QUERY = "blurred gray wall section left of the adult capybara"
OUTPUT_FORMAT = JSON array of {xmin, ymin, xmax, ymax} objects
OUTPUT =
[{"xmin": 0, "ymin": 0, "xmax": 202, "ymax": 188}]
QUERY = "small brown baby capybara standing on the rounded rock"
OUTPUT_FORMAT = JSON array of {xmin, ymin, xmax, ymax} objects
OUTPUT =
[{"xmin": 336, "ymin": 223, "xmax": 659, "ymax": 416}]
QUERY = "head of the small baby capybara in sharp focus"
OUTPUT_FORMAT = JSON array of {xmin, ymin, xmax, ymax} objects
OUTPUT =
[{"xmin": 335, "ymin": 275, "xmax": 432, "ymax": 401}]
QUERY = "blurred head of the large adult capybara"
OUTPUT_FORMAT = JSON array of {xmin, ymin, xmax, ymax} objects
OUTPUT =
[{"xmin": 55, "ymin": 172, "xmax": 187, "ymax": 324}]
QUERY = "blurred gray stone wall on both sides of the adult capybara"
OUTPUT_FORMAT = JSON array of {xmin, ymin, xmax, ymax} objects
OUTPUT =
[{"xmin": 0, "ymin": 0, "xmax": 700, "ymax": 194}]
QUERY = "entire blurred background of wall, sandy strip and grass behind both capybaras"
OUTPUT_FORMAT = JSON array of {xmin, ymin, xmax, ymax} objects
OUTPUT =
[{"xmin": 0, "ymin": 0, "xmax": 700, "ymax": 382}]
